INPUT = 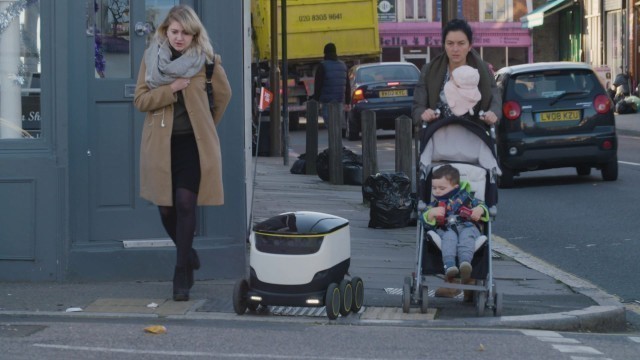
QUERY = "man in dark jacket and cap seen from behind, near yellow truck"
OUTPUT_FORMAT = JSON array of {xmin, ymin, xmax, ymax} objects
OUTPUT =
[{"xmin": 313, "ymin": 43, "xmax": 351, "ymax": 122}]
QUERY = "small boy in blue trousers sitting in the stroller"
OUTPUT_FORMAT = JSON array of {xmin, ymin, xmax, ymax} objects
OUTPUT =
[{"xmin": 422, "ymin": 165, "xmax": 489, "ymax": 282}]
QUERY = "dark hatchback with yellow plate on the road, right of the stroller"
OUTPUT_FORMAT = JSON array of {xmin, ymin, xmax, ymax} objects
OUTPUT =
[{"xmin": 496, "ymin": 62, "xmax": 618, "ymax": 188}]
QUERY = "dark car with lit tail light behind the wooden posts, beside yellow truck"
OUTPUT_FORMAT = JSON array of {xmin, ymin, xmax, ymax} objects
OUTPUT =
[{"xmin": 342, "ymin": 62, "xmax": 420, "ymax": 140}]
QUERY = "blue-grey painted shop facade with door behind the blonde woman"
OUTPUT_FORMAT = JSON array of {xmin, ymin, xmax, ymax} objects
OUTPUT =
[{"xmin": 0, "ymin": 0, "xmax": 251, "ymax": 281}]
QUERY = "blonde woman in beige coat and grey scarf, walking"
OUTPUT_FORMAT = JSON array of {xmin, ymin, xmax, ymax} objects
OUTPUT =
[{"xmin": 134, "ymin": 5, "xmax": 231, "ymax": 301}]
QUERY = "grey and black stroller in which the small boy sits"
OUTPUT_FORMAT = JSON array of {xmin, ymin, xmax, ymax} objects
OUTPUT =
[{"xmin": 402, "ymin": 116, "xmax": 502, "ymax": 316}]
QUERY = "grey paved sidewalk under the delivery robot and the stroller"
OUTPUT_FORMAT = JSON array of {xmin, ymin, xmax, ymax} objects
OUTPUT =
[{"xmin": 0, "ymin": 114, "xmax": 640, "ymax": 331}]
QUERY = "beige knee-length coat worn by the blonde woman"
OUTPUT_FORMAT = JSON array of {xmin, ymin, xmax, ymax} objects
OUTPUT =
[{"xmin": 134, "ymin": 55, "xmax": 231, "ymax": 206}]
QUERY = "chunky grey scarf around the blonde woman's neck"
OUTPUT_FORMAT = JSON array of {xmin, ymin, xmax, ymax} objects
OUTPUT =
[{"xmin": 144, "ymin": 38, "xmax": 206, "ymax": 89}]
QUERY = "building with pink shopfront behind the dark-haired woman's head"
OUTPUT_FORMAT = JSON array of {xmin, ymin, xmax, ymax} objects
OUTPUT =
[{"xmin": 378, "ymin": 0, "xmax": 534, "ymax": 70}]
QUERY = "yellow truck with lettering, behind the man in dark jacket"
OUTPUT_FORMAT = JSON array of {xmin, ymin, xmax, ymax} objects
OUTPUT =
[{"xmin": 251, "ymin": 0, "xmax": 380, "ymax": 129}]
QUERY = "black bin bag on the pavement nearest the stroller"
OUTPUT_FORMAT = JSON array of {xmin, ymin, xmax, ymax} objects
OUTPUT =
[{"xmin": 362, "ymin": 172, "xmax": 415, "ymax": 228}]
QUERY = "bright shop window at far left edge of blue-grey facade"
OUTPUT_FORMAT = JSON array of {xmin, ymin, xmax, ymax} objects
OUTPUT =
[{"xmin": 0, "ymin": 0, "xmax": 41, "ymax": 140}]
